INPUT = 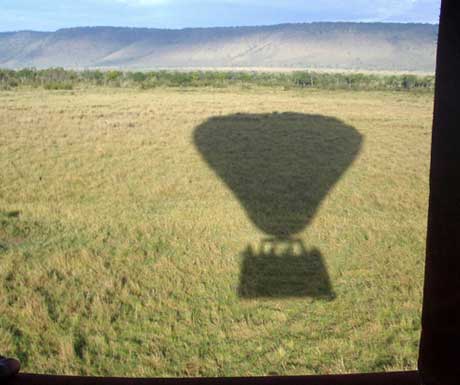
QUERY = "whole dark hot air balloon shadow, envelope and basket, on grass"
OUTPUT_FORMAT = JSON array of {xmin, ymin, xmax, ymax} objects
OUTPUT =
[{"xmin": 194, "ymin": 112, "xmax": 362, "ymax": 299}]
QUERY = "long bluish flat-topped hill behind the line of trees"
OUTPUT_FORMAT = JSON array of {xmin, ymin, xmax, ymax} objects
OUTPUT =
[{"xmin": 0, "ymin": 23, "xmax": 438, "ymax": 72}]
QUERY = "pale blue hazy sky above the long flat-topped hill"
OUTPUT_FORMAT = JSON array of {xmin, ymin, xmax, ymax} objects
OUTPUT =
[{"xmin": 0, "ymin": 0, "xmax": 441, "ymax": 31}]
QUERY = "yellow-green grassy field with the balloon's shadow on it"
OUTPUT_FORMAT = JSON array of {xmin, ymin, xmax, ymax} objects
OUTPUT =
[{"xmin": 0, "ymin": 88, "xmax": 432, "ymax": 376}]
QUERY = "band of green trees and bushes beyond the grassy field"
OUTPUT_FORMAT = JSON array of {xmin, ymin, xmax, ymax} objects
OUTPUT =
[{"xmin": 0, "ymin": 68, "xmax": 435, "ymax": 91}]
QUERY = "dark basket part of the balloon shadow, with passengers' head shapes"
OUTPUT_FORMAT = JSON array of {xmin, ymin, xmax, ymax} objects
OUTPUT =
[{"xmin": 238, "ymin": 239, "xmax": 335, "ymax": 300}]
